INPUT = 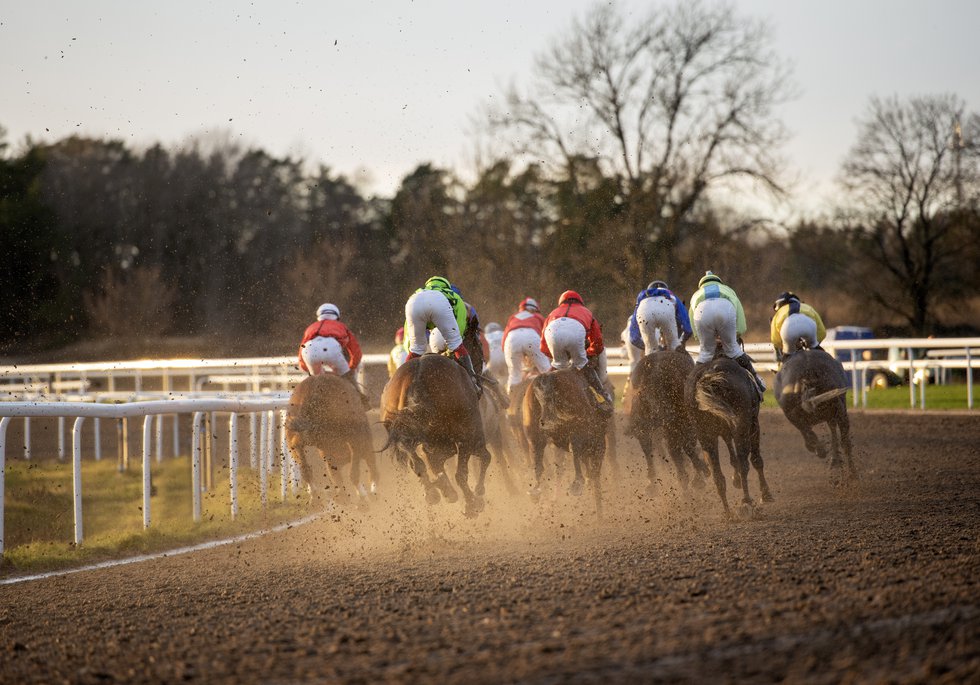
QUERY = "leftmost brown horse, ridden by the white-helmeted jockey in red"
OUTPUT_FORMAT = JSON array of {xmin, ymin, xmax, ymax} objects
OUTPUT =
[{"xmin": 286, "ymin": 373, "xmax": 378, "ymax": 497}]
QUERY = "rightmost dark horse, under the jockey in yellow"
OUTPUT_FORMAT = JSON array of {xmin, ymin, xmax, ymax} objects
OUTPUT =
[{"xmin": 773, "ymin": 344, "xmax": 857, "ymax": 480}]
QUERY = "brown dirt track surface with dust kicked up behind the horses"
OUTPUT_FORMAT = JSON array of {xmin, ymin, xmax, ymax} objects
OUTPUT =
[{"xmin": 0, "ymin": 411, "xmax": 980, "ymax": 683}]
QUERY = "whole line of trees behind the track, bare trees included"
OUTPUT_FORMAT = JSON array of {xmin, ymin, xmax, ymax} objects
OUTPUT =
[{"xmin": 0, "ymin": 3, "xmax": 980, "ymax": 356}]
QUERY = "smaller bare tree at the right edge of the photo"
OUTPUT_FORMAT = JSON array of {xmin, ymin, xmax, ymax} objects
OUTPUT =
[{"xmin": 841, "ymin": 95, "xmax": 980, "ymax": 334}]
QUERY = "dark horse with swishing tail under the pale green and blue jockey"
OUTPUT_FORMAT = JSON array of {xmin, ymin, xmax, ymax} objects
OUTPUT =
[{"xmin": 685, "ymin": 356, "xmax": 773, "ymax": 516}]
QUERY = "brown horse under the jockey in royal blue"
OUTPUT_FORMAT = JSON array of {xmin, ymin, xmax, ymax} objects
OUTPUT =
[{"xmin": 627, "ymin": 350, "xmax": 710, "ymax": 493}]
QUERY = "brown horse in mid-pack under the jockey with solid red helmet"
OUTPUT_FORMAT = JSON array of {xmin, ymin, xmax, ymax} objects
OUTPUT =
[{"xmin": 522, "ymin": 369, "xmax": 611, "ymax": 515}]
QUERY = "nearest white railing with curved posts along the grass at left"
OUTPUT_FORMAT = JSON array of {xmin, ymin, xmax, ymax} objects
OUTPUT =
[{"xmin": 0, "ymin": 395, "xmax": 292, "ymax": 555}]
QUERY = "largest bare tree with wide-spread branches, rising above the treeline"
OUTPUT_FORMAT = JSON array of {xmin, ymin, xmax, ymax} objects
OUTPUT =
[{"xmin": 490, "ymin": 1, "xmax": 791, "ymax": 285}]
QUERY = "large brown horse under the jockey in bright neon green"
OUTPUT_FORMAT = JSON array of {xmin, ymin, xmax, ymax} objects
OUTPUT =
[{"xmin": 381, "ymin": 354, "xmax": 490, "ymax": 516}]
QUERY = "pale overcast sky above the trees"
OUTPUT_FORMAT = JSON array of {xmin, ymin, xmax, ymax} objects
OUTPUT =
[{"xmin": 0, "ymin": 0, "xmax": 980, "ymax": 216}]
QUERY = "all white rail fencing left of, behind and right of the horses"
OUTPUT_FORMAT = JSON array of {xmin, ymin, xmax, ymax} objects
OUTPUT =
[{"xmin": 0, "ymin": 338, "xmax": 980, "ymax": 554}]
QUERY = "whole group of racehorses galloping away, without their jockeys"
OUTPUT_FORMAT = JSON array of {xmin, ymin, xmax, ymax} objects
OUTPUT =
[{"xmin": 286, "ymin": 320, "xmax": 856, "ymax": 517}]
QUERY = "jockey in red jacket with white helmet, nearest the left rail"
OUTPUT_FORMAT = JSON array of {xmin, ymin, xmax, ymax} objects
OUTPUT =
[{"xmin": 299, "ymin": 302, "xmax": 367, "ymax": 405}]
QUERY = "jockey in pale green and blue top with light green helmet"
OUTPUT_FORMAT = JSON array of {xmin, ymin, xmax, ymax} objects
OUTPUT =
[{"xmin": 691, "ymin": 271, "xmax": 766, "ymax": 395}]
